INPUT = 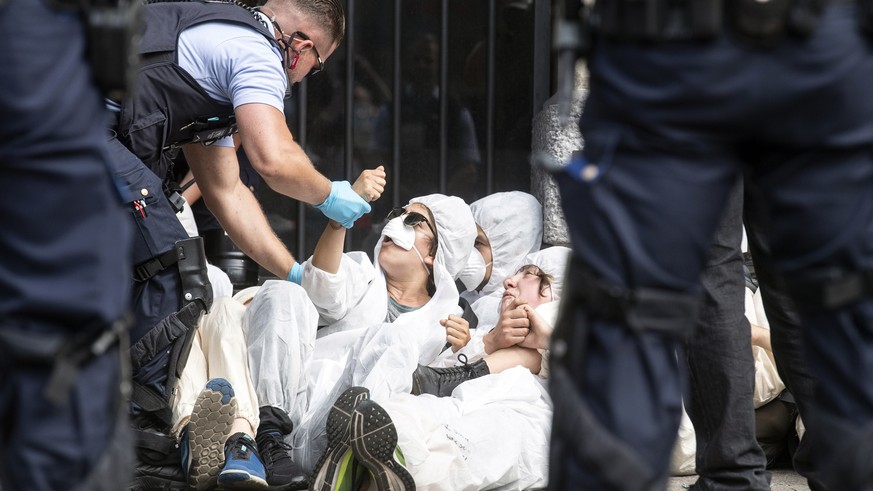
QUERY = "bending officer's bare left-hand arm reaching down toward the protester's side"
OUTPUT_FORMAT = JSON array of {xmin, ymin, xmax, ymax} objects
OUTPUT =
[{"xmin": 184, "ymin": 143, "xmax": 294, "ymax": 278}]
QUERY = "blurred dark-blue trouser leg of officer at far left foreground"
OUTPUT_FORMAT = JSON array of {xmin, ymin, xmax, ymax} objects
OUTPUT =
[{"xmin": 0, "ymin": 0, "xmax": 133, "ymax": 491}]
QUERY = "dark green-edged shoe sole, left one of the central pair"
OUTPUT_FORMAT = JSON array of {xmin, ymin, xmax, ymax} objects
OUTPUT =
[{"xmin": 310, "ymin": 387, "xmax": 370, "ymax": 491}]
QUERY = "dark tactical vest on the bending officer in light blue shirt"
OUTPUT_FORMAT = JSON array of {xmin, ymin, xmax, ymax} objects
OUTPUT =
[{"xmin": 117, "ymin": 1, "xmax": 281, "ymax": 179}]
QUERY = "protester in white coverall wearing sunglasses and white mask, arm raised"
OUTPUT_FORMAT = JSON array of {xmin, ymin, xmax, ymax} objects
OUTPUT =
[{"xmin": 243, "ymin": 183, "xmax": 475, "ymax": 482}]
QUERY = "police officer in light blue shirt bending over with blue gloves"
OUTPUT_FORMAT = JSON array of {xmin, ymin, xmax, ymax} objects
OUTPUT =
[{"xmin": 110, "ymin": 0, "xmax": 370, "ymax": 486}]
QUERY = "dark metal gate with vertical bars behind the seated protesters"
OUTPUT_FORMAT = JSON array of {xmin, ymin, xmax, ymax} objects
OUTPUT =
[{"xmin": 258, "ymin": 0, "xmax": 551, "ymax": 260}]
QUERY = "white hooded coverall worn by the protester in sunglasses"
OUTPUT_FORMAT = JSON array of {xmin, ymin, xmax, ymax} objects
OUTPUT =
[{"xmin": 243, "ymin": 194, "xmax": 476, "ymax": 473}]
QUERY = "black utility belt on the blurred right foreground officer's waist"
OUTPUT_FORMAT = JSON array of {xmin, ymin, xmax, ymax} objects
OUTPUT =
[{"xmin": 588, "ymin": 0, "xmax": 852, "ymax": 45}]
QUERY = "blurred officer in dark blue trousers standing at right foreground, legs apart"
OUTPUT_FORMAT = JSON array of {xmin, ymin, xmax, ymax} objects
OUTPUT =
[{"xmin": 549, "ymin": 0, "xmax": 873, "ymax": 491}]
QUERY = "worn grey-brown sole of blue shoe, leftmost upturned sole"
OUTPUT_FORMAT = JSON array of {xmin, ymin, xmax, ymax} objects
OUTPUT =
[{"xmin": 188, "ymin": 380, "xmax": 237, "ymax": 491}]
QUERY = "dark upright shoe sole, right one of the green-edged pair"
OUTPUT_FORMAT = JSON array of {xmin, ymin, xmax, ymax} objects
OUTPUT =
[{"xmin": 352, "ymin": 401, "xmax": 415, "ymax": 491}]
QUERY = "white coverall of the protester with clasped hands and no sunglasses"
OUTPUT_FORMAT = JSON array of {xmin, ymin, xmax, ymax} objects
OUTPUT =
[{"xmin": 380, "ymin": 246, "xmax": 571, "ymax": 491}]
